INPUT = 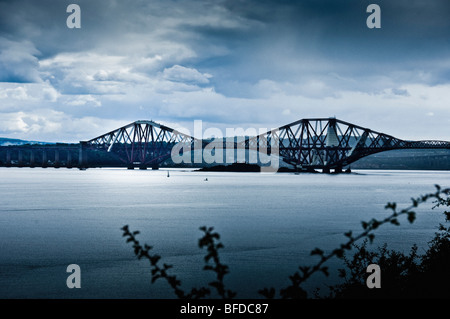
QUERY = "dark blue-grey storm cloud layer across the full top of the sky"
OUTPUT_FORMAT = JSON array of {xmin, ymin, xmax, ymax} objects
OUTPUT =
[{"xmin": 0, "ymin": 0, "xmax": 450, "ymax": 85}]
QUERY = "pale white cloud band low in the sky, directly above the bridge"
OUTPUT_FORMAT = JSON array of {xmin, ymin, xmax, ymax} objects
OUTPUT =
[{"xmin": 0, "ymin": 79, "xmax": 450, "ymax": 141}]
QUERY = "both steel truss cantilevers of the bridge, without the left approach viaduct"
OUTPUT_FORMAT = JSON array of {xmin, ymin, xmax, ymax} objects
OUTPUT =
[{"xmin": 81, "ymin": 118, "xmax": 450, "ymax": 172}]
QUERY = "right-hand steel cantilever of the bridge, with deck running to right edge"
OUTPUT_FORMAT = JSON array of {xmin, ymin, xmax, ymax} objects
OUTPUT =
[{"xmin": 247, "ymin": 118, "xmax": 450, "ymax": 171}]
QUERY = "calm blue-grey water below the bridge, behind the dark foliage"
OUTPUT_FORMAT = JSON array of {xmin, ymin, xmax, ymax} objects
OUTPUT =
[{"xmin": 0, "ymin": 168, "xmax": 450, "ymax": 298}]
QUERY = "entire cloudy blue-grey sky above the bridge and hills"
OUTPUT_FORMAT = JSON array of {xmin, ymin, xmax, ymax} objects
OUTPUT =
[{"xmin": 0, "ymin": 0, "xmax": 450, "ymax": 142}]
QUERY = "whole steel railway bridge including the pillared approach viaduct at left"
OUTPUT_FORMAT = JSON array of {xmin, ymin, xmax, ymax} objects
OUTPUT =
[{"xmin": 0, "ymin": 118, "xmax": 450, "ymax": 173}]
